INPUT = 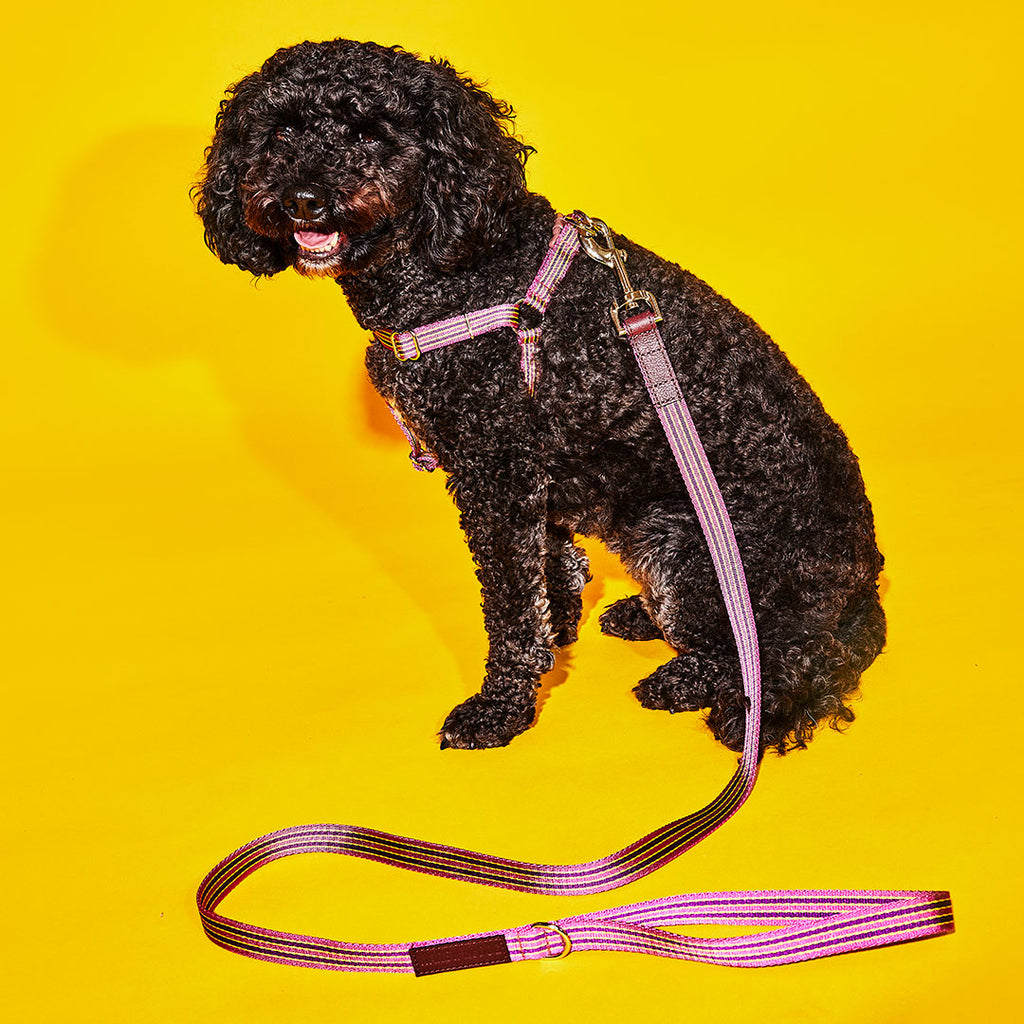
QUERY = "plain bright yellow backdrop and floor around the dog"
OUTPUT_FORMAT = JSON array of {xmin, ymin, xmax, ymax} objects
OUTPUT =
[{"xmin": 0, "ymin": 0, "xmax": 1022, "ymax": 1024}]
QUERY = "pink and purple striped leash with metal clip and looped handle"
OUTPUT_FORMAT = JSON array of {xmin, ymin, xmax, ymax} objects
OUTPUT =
[{"xmin": 197, "ymin": 213, "xmax": 953, "ymax": 975}]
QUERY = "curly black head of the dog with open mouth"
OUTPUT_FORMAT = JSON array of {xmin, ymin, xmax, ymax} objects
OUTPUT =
[{"xmin": 194, "ymin": 39, "xmax": 530, "ymax": 276}]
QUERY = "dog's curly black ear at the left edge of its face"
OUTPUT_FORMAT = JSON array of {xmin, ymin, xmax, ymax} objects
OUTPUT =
[{"xmin": 191, "ymin": 82, "xmax": 289, "ymax": 276}]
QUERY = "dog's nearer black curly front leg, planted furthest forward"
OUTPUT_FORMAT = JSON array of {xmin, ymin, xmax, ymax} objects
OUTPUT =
[{"xmin": 440, "ymin": 450, "xmax": 554, "ymax": 749}]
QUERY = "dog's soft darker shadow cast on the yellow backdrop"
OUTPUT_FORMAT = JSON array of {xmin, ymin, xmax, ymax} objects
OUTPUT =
[{"xmin": 41, "ymin": 127, "xmax": 638, "ymax": 724}]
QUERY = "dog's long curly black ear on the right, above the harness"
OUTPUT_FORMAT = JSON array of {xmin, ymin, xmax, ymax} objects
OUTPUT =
[{"xmin": 421, "ymin": 60, "xmax": 534, "ymax": 270}]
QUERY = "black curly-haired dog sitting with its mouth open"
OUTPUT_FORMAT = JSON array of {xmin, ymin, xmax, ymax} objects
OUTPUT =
[{"xmin": 196, "ymin": 39, "xmax": 885, "ymax": 753}]
